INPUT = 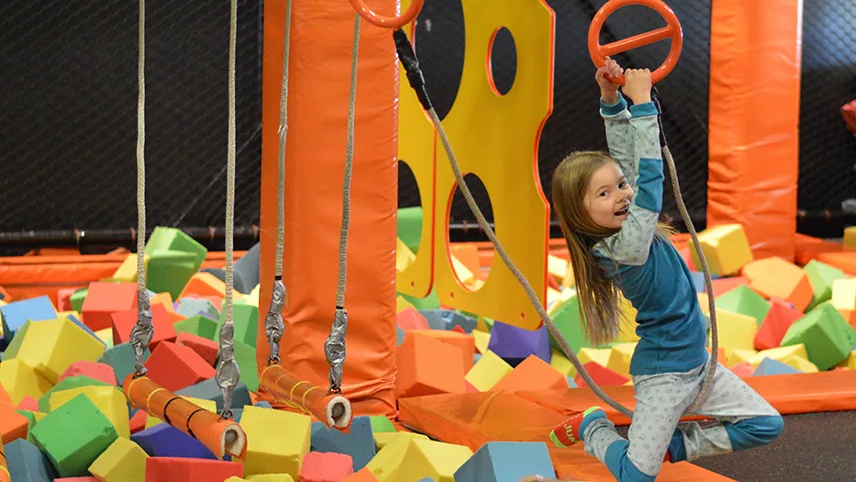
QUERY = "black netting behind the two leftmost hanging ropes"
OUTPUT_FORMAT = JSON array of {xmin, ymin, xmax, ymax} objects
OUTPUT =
[{"xmin": 0, "ymin": 0, "xmax": 262, "ymax": 231}]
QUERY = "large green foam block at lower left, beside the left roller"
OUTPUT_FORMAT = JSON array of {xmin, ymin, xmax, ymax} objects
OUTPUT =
[{"xmin": 33, "ymin": 394, "xmax": 119, "ymax": 477}]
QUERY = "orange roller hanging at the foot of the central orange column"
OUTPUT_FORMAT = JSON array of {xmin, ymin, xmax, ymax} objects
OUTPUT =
[{"xmin": 259, "ymin": 365, "xmax": 352, "ymax": 433}]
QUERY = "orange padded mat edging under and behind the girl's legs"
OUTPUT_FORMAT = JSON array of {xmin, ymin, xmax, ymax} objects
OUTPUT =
[{"xmin": 399, "ymin": 371, "xmax": 856, "ymax": 481}]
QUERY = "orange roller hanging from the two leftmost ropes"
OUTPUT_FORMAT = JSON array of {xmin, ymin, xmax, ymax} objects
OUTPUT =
[{"xmin": 122, "ymin": 373, "xmax": 247, "ymax": 459}]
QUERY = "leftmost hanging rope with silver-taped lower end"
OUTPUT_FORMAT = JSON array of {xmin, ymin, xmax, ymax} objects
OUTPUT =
[{"xmin": 129, "ymin": 0, "xmax": 154, "ymax": 377}]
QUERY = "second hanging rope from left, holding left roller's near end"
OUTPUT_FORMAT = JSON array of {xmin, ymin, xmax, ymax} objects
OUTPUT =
[{"xmin": 215, "ymin": 0, "xmax": 241, "ymax": 419}]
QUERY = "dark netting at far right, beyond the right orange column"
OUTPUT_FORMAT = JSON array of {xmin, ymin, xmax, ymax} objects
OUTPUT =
[{"xmin": 798, "ymin": 0, "xmax": 856, "ymax": 210}]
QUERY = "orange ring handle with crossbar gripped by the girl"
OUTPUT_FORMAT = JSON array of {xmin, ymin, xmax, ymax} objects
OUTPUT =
[{"xmin": 588, "ymin": 0, "xmax": 684, "ymax": 85}]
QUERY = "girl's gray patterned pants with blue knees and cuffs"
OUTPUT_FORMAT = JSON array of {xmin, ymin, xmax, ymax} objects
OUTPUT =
[{"xmin": 583, "ymin": 360, "xmax": 783, "ymax": 481}]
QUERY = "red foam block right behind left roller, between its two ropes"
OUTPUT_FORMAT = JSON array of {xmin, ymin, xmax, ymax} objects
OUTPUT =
[{"xmin": 145, "ymin": 341, "xmax": 216, "ymax": 391}]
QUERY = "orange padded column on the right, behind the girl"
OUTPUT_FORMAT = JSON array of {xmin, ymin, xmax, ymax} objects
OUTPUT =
[{"xmin": 707, "ymin": 0, "xmax": 803, "ymax": 260}]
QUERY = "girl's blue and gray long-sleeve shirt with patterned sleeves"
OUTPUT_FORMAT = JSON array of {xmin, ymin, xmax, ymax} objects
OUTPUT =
[{"xmin": 594, "ymin": 94, "xmax": 708, "ymax": 375}]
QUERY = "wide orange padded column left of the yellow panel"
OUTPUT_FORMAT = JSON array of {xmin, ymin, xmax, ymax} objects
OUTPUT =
[{"xmin": 256, "ymin": 0, "xmax": 398, "ymax": 415}]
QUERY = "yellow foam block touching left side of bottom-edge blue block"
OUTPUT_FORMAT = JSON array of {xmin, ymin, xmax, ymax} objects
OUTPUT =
[{"xmin": 399, "ymin": 439, "xmax": 473, "ymax": 482}]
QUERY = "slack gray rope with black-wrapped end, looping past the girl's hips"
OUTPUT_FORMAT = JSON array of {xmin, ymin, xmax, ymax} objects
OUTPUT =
[{"xmin": 393, "ymin": 29, "xmax": 718, "ymax": 418}]
